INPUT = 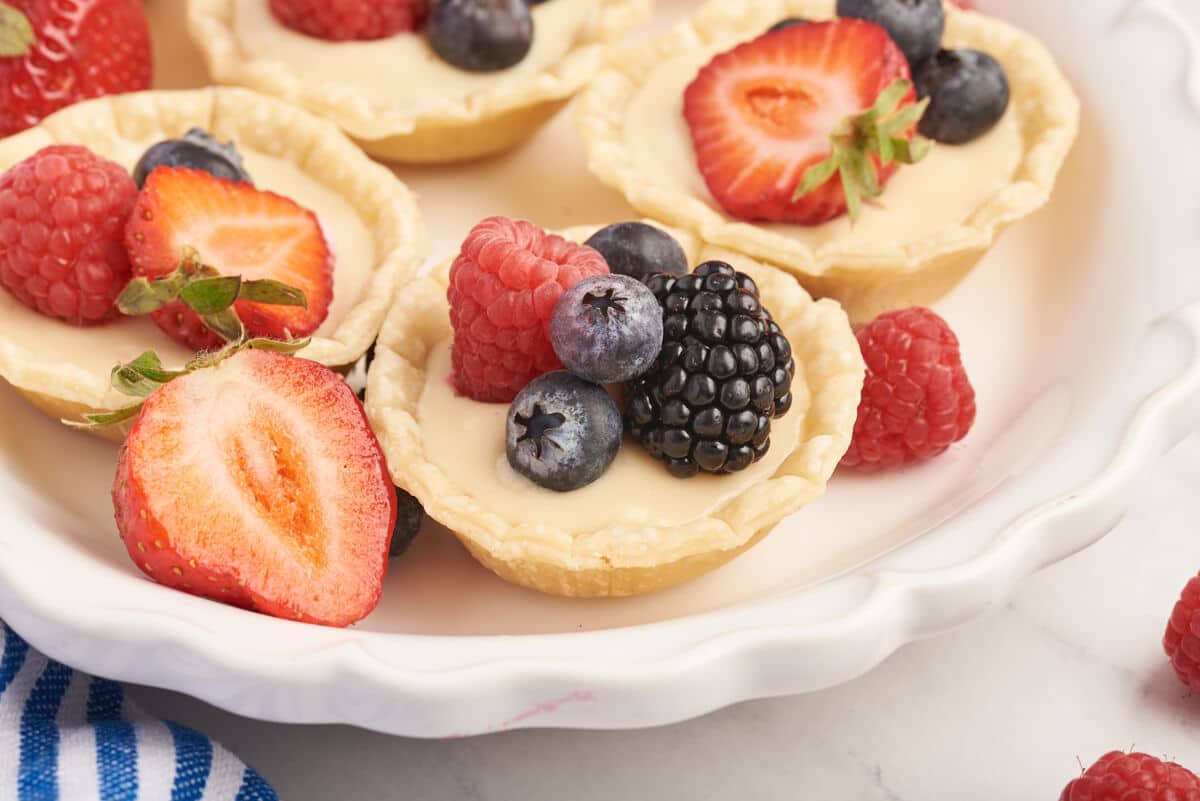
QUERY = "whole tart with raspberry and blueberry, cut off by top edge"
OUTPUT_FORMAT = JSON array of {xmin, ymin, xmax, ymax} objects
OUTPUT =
[{"xmin": 188, "ymin": 0, "xmax": 650, "ymax": 163}]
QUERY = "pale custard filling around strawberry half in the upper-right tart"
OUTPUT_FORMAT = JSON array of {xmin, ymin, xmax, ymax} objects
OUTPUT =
[{"xmin": 622, "ymin": 42, "xmax": 1025, "ymax": 251}]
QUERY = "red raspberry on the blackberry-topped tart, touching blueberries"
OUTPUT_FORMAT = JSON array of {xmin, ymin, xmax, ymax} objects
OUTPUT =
[{"xmin": 446, "ymin": 217, "xmax": 608, "ymax": 403}]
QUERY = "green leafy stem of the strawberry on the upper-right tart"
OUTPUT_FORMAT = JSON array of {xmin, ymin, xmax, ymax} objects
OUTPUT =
[{"xmin": 792, "ymin": 78, "xmax": 931, "ymax": 222}]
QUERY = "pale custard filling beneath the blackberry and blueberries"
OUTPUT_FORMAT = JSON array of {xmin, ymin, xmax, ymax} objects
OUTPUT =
[{"xmin": 416, "ymin": 339, "xmax": 804, "ymax": 536}]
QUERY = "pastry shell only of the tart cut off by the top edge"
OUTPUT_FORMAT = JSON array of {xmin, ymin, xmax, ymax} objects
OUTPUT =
[{"xmin": 187, "ymin": 0, "xmax": 652, "ymax": 164}]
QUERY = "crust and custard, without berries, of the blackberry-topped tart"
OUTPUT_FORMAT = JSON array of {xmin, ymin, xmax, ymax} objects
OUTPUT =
[{"xmin": 366, "ymin": 228, "xmax": 864, "ymax": 597}]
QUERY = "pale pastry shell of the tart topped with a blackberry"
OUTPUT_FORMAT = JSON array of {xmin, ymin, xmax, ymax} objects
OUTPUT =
[{"xmin": 366, "ymin": 228, "xmax": 864, "ymax": 597}]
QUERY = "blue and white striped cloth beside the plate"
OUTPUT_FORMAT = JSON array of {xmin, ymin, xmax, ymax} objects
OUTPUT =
[{"xmin": 0, "ymin": 622, "xmax": 278, "ymax": 801}]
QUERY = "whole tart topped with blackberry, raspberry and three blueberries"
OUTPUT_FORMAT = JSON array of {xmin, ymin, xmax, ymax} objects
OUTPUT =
[{"xmin": 366, "ymin": 217, "xmax": 864, "ymax": 597}]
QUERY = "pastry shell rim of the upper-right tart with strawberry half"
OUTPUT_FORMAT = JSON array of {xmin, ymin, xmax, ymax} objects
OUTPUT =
[{"xmin": 578, "ymin": 0, "xmax": 1080, "ymax": 324}]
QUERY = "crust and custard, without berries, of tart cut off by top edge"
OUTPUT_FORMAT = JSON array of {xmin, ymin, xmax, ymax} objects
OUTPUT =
[{"xmin": 187, "ymin": 0, "xmax": 652, "ymax": 163}]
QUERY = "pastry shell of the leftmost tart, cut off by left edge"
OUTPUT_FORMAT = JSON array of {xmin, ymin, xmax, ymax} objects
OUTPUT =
[{"xmin": 0, "ymin": 88, "xmax": 428, "ymax": 441}]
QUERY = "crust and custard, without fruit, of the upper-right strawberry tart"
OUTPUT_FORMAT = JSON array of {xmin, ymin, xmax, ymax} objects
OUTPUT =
[{"xmin": 578, "ymin": 0, "xmax": 1079, "ymax": 324}]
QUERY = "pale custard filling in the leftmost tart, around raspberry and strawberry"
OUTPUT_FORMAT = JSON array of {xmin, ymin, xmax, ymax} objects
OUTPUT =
[{"xmin": 0, "ymin": 140, "xmax": 376, "ymax": 381}]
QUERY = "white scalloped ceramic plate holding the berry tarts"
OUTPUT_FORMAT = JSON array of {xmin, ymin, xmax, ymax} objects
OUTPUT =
[{"xmin": 0, "ymin": 0, "xmax": 1200, "ymax": 736}]
